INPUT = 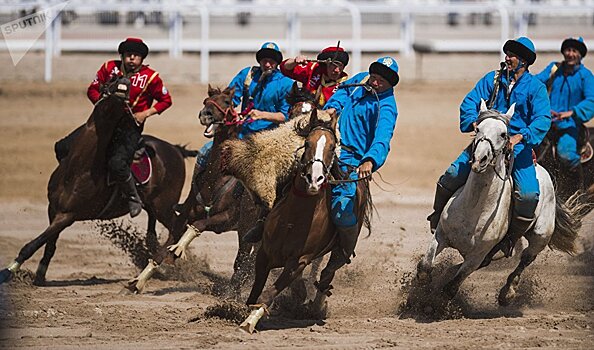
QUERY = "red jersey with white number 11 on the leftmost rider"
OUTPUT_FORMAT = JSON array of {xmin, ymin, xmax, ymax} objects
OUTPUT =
[{"xmin": 87, "ymin": 61, "xmax": 172, "ymax": 114}]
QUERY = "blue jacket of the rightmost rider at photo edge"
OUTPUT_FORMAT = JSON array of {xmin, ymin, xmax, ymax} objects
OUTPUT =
[{"xmin": 536, "ymin": 62, "xmax": 594, "ymax": 129}]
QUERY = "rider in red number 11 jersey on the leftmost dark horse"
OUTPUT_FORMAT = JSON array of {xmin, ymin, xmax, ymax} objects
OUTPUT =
[{"xmin": 55, "ymin": 38, "xmax": 172, "ymax": 217}]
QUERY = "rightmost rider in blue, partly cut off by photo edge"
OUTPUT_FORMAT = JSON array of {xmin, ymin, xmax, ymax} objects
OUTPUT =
[{"xmin": 536, "ymin": 37, "xmax": 594, "ymax": 195}]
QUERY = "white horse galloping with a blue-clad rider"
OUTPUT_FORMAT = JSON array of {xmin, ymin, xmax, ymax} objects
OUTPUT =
[{"xmin": 417, "ymin": 101, "xmax": 581, "ymax": 305}]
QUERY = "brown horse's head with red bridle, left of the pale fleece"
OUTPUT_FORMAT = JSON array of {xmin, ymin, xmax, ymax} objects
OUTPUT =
[{"xmin": 198, "ymin": 85, "xmax": 239, "ymax": 138}]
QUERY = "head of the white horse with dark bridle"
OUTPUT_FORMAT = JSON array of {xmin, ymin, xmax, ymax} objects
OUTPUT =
[{"xmin": 471, "ymin": 100, "xmax": 515, "ymax": 173}]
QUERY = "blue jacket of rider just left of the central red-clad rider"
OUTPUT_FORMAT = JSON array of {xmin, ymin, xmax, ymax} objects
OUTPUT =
[{"xmin": 229, "ymin": 67, "xmax": 293, "ymax": 136}]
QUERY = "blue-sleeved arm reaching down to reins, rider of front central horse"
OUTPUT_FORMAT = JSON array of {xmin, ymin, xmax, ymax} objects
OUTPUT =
[{"xmin": 361, "ymin": 98, "xmax": 398, "ymax": 171}]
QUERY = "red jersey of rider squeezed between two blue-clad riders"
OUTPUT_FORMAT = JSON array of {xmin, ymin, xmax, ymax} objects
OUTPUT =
[{"xmin": 280, "ymin": 60, "xmax": 348, "ymax": 106}]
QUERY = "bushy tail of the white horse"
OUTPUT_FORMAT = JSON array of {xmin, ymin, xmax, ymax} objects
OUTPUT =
[{"xmin": 549, "ymin": 192, "xmax": 592, "ymax": 255}]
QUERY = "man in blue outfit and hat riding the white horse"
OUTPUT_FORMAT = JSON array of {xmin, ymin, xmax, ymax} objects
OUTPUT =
[{"xmin": 427, "ymin": 37, "xmax": 551, "ymax": 261}]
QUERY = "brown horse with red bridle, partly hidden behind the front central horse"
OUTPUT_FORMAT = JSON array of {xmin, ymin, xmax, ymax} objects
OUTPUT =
[{"xmin": 128, "ymin": 86, "xmax": 256, "ymax": 295}]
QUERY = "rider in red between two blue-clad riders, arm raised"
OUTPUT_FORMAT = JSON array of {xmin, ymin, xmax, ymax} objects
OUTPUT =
[{"xmin": 280, "ymin": 46, "xmax": 349, "ymax": 107}]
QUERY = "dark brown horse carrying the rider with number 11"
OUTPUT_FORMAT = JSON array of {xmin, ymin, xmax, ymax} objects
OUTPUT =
[{"xmin": 0, "ymin": 77, "xmax": 191, "ymax": 285}]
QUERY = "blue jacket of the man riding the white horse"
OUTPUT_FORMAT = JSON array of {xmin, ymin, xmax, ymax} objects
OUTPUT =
[{"xmin": 460, "ymin": 71, "xmax": 551, "ymax": 148}]
